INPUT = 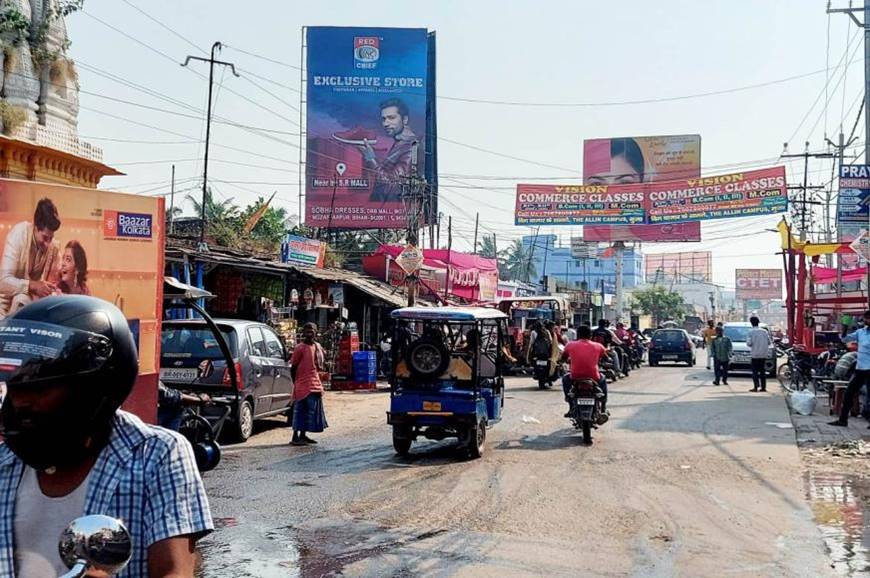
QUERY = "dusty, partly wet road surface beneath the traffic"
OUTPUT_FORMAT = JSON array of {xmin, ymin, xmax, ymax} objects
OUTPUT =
[{"xmin": 200, "ymin": 352, "xmax": 832, "ymax": 577}]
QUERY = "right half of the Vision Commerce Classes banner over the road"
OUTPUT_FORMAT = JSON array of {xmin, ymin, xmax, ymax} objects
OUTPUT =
[{"xmin": 646, "ymin": 167, "xmax": 788, "ymax": 224}]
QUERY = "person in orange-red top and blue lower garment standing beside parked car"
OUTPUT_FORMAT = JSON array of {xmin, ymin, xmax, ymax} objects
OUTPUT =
[{"xmin": 290, "ymin": 323, "xmax": 328, "ymax": 446}]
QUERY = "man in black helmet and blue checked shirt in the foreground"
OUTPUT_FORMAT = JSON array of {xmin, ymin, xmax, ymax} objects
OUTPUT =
[{"xmin": 0, "ymin": 295, "xmax": 214, "ymax": 578}]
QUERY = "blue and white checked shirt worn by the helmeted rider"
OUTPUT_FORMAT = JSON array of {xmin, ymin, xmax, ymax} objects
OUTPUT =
[{"xmin": 0, "ymin": 410, "xmax": 214, "ymax": 578}]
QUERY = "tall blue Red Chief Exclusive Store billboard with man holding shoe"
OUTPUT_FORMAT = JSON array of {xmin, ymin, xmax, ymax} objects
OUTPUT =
[{"xmin": 305, "ymin": 27, "xmax": 434, "ymax": 229}]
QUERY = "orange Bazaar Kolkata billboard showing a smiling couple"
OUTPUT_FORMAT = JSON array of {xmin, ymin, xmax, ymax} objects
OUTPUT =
[{"xmin": 0, "ymin": 179, "xmax": 165, "ymax": 421}]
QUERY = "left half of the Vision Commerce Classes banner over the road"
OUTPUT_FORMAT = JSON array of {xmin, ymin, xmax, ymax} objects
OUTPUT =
[{"xmin": 514, "ymin": 184, "xmax": 644, "ymax": 225}]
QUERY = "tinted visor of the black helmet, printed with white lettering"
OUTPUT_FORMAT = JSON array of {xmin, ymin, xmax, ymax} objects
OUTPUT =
[{"xmin": 0, "ymin": 318, "xmax": 112, "ymax": 386}]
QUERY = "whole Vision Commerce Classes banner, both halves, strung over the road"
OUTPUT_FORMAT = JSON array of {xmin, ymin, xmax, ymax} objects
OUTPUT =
[{"xmin": 515, "ymin": 167, "xmax": 788, "ymax": 225}]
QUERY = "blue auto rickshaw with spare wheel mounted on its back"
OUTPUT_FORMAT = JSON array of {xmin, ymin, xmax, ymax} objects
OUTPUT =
[{"xmin": 387, "ymin": 307, "xmax": 507, "ymax": 458}]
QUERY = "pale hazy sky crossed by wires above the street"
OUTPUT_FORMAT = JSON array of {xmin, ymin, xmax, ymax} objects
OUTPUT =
[{"xmin": 67, "ymin": 0, "xmax": 863, "ymax": 286}]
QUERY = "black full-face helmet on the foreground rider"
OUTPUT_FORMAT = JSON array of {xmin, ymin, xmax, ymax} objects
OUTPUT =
[{"xmin": 0, "ymin": 295, "xmax": 139, "ymax": 469}]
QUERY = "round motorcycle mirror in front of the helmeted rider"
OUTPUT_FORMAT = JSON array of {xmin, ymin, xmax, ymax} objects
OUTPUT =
[{"xmin": 58, "ymin": 515, "xmax": 133, "ymax": 578}]
